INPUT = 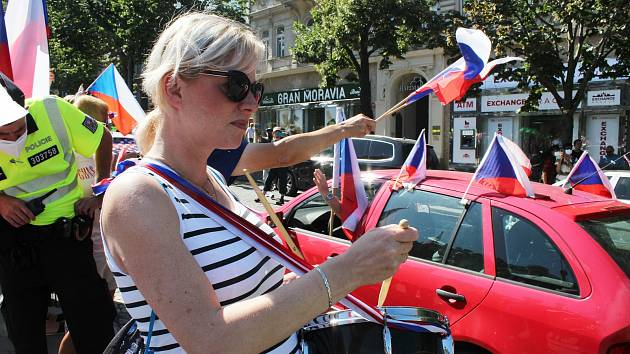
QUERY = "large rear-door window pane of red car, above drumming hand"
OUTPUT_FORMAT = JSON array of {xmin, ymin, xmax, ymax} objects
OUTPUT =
[{"xmin": 378, "ymin": 189, "xmax": 464, "ymax": 262}]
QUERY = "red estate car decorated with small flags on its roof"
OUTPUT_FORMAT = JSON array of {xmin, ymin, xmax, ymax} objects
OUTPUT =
[{"xmin": 266, "ymin": 171, "xmax": 630, "ymax": 354}]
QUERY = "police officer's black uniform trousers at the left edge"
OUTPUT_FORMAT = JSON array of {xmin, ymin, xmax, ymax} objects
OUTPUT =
[{"xmin": 0, "ymin": 224, "xmax": 115, "ymax": 354}]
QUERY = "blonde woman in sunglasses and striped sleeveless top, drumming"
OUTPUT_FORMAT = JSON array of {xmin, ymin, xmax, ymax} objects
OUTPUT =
[{"xmin": 102, "ymin": 13, "xmax": 418, "ymax": 354}]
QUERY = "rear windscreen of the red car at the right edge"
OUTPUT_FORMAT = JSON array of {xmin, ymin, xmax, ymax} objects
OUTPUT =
[{"xmin": 579, "ymin": 215, "xmax": 630, "ymax": 278}]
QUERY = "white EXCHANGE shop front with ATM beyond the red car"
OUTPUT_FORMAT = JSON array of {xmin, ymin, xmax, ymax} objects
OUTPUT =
[{"xmin": 450, "ymin": 68, "xmax": 630, "ymax": 170}]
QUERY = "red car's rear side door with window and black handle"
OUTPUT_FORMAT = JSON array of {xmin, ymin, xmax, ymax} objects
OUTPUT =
[{"xmin": 358, "ymin": 186, "xmax": 493, "ymax": 324}]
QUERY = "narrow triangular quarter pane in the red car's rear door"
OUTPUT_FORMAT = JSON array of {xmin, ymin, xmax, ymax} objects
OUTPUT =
[{"xmin": 446, "ymin": 203, "xmax": 483, "ymax": 272}]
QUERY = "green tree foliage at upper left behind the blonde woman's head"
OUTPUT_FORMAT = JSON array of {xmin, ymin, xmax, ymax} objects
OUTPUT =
[{"xmin": 47, "ymin": 0, "xmax": 247, "ymax": 99}]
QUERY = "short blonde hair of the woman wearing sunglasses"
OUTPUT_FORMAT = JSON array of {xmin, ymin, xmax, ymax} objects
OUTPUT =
[{"xmin": 142, "ymin": 12, "xmax": 264, "ymax": 107}]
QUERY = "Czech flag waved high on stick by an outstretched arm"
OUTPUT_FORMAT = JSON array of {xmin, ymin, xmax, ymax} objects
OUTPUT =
[{"xmin": 404, "ymin": 27, "xmax": 523, "ymax": 106}]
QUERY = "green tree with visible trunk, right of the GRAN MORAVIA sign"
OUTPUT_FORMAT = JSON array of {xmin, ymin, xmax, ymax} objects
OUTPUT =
[{"xmin": 292, "ymin": 0, "xmax": 443, "ymax": 116}]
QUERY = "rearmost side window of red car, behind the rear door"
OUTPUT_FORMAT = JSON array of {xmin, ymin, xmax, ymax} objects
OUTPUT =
[{"xmin": 492, "ymin": 208, "xmax": 579, "ymax": 295}]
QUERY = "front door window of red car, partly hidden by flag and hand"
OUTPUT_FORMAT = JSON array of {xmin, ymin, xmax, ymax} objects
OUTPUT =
[{"xmin": 286, "ymin": 180, "xmax": 383, "ymax": 239}]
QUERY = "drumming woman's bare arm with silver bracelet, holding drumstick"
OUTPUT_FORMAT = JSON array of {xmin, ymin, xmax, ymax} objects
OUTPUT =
[{"xmin": 102, "ymin": 173, "xmax": 417, "ymax": 353}]
